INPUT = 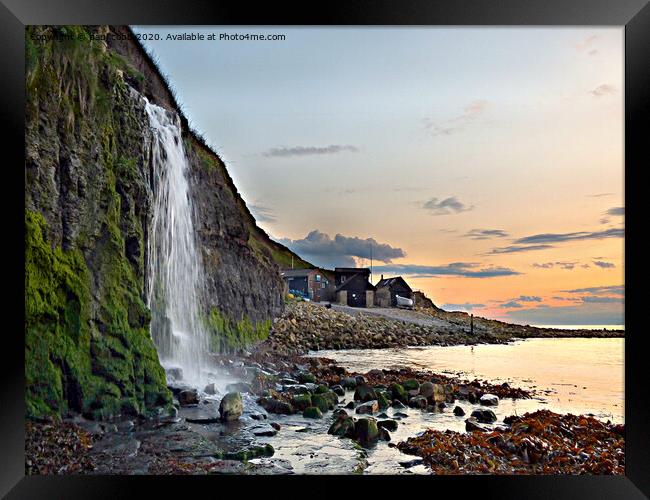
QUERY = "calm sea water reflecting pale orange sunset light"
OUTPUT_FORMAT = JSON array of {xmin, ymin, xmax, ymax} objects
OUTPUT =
[{"xmin": 313, "ymin": 338, "xmax": 625, "ymax": 423}]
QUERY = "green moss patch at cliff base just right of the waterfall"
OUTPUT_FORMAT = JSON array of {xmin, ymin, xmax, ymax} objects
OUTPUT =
[{"xmin": 206, "ymin": 308, "xmax": 271, "ymax": 352}]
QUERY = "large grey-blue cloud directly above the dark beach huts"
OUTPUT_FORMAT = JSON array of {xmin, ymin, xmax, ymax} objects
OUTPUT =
[{"xmin": 277, "ymin": 229, "xmax": 406, "ymax": 267}]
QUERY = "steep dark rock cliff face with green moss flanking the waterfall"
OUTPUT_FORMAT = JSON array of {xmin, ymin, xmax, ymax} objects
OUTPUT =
[{"xmin": 25, "ymin": 27, "xmax": 288, "ymax": 418}]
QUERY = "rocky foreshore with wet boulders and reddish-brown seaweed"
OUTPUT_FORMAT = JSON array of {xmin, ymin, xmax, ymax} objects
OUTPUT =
[{"xmin": 26, "ymin": 350, "xmax": 624, "ymax": 474}]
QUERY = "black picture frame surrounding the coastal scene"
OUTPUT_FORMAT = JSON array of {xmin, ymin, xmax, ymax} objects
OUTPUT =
[{"xmin": 0, "ymin": 0, "xmax": 650, "ymax": 500}]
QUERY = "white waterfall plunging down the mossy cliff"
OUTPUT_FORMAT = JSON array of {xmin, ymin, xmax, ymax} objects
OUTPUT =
[{"xmin": 145, "ymin": 99, "xmax": 209, "ymax": 385}]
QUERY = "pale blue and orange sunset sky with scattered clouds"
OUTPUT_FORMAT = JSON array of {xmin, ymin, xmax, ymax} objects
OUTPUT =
[{"xmin": 134, "ymin": 26, "xmax": 625, "ymax": 325}]
